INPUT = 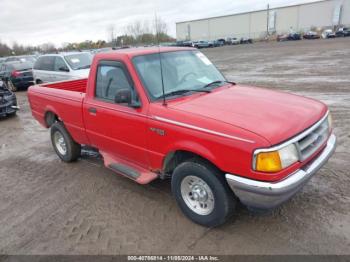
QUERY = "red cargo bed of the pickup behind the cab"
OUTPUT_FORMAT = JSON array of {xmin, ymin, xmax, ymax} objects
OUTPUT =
[{"xmin": 28, "ymin": 79, "xmax": 88, "ymax": 144}]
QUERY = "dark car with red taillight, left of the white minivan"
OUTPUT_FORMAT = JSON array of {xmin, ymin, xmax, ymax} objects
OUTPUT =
[{"xmin": 0, "ymin": 61, "xmax": 34, "ymax": 92}]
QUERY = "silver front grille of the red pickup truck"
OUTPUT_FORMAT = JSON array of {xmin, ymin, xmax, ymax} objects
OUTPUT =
[{"xmin": 295, "ymin": 118, "xmax": 329, "ymax": 161}]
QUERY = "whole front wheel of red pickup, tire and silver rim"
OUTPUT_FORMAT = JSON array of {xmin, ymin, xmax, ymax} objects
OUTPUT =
[{"xmin": 171, "ymin": 160, "xmax": 237, "ymax": 227}]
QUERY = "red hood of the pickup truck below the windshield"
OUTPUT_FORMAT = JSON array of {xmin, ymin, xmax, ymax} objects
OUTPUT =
[{"xmin": 168, "ymin": 86, "xmax": 327, "ymax": 145}]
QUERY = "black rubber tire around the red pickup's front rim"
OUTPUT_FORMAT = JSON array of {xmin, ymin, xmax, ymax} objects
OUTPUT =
[{"xmin": 171, "ymin": 159, "xmax": 237, "ymax": 227}]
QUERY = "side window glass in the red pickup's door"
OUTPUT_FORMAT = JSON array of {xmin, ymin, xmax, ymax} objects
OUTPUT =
[{"xmin": 95, "ymin": 65, "xmax": 134, "ymax": 102}]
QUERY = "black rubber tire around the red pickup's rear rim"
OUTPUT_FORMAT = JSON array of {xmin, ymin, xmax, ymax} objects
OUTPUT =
[{"xmin": 51, "ymin": 122, "xmax": 81, "ymax": 163}]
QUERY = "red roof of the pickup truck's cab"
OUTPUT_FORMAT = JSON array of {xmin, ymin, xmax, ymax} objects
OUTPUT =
[{"xmin": 95, "ymin": 46, "xmax": 197, "ymax": 59}]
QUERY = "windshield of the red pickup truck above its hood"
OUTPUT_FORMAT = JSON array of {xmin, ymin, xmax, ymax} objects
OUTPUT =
[{"xmin": 133, "ymin": 51, "xmax": 226, "ymax": 101}]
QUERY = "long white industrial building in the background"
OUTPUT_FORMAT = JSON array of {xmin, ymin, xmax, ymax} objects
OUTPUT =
[{"xmin": 176, "ymin": 0, "xmax": 350, "ymax": 41}]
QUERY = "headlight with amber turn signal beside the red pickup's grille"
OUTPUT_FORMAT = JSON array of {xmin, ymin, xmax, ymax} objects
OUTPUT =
[{"xmin": 255, "ymin": 144, "xmax": 299, "ymax": 173}]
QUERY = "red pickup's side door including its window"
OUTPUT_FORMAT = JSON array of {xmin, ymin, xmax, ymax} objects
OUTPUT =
[{"xmin": 84, "ymin": 61, "xmax": 148, "ymax": 167}]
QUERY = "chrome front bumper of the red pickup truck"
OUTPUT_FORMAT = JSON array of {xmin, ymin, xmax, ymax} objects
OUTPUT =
[{"xmin": 226, "ymin": 134, "xmax": 337, "ymax": 209}]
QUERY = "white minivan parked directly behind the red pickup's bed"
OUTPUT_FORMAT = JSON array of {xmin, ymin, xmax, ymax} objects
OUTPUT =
[{"xmin": 33, "ymin": 52, "xmax": 92, "ymax": 84}]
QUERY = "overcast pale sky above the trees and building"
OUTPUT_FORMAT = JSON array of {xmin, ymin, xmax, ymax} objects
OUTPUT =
[{"xmin": 0, "ymin": 0, "xmax": 322, "ymax": 46}]
